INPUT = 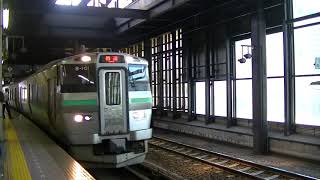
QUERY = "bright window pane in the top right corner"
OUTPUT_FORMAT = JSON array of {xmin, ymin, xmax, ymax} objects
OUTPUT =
[{"xmin": 293, "ymin": 0, "xmax": 320, "ymax": 18}]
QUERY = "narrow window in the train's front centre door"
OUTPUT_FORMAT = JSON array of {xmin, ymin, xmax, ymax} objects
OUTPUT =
[{"xmin": 105, "ymin": 72, "xmax": 121, "ymax": 105}]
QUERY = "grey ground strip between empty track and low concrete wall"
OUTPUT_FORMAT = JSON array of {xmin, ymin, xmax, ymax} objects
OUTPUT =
[{"xmin": 153, "ymin": 129, "xmax": 320, "ymax": 179}]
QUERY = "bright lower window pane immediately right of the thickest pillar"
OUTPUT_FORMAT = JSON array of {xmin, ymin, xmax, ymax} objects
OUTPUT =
[{"xmin": 267, "ymin": 78, "xmax": 284, "ymax": 122}]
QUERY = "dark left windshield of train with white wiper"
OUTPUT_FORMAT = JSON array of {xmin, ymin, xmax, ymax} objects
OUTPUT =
[{"xmin": 61, "ymin": 64, "xmax": 97, "ymax": 93}]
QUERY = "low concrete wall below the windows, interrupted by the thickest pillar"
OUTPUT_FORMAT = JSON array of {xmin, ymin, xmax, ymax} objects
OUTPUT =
[{"xmin": 153, "ymin": 119, "xmax": 320, "ymax": 161}]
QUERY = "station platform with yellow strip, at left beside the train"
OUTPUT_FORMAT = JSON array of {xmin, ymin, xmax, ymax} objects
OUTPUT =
[{"xmin": 0, "ymin": 113, "xmax": 94, "ymax": 180}]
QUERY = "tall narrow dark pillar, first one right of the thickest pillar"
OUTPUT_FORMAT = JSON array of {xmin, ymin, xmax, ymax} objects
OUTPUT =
[{"xmin": 283, "ymin": 0, "xmax": 296, "ymax": 136}]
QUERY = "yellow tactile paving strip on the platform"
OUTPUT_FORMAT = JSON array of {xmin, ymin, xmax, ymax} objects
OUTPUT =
[{"xmin": 4, "ymin": 119, "xmax": 31, "ymax": 180}]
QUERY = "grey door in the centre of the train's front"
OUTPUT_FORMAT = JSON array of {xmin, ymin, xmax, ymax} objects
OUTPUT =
[{"xmin": 99, "ymin": 69, "xmax": 128, "ymax": 135}]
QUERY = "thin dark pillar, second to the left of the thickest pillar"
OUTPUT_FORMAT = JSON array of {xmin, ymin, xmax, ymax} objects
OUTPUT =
[{"xmin": 205, "ymin": 29, "xmax": 212, "ymax": 124}]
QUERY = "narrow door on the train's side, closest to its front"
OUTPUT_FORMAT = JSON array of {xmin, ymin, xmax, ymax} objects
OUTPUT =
[{"xmin": 48, "ymin": 79, "xmax": 57, "ymax": 125}]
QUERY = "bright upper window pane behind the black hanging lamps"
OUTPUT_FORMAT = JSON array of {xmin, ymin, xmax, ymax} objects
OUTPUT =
[{"xmin": 235, "ymin": 39, "xmax": 252, "ymax": 78}]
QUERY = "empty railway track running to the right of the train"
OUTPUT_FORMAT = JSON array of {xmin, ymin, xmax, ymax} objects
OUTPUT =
[{"xmin": 149, "ymin": 136, "xmax": 317, "ymax": 180}]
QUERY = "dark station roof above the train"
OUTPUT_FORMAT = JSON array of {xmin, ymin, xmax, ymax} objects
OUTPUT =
[{"xmin": 6, "ymin": 0, "xmax": 280, "ymax": 64}]
